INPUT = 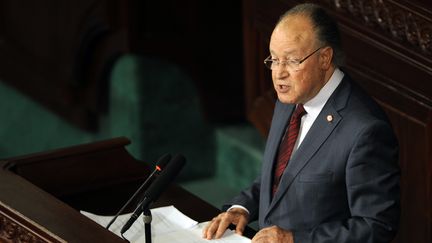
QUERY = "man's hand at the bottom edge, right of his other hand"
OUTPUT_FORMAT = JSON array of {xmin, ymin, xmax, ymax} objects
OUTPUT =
[{"xmin": 252, "ymin": 226, "xmax": 294, "ymax": 243}]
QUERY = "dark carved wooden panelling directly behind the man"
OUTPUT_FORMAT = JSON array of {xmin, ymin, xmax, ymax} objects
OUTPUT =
[{"xmin": 243, "ymin": 0, "xmax": 432, "ymax": 243}]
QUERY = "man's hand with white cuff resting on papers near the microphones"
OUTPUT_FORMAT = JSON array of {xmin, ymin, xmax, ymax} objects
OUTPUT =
[{"xmin": 203, "ymin": 208, "xmax": 249, "ymax": 240}]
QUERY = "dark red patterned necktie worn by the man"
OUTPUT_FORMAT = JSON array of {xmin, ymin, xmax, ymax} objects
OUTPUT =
[{"xmin": 272, "ymin": 104, "xmax": 306, "ymax": 195}]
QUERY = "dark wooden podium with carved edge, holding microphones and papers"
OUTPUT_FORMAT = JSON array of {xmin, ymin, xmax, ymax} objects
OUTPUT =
[{"xmin": 0, "ymin": 138, "xmax": 219, "ymax": 243}]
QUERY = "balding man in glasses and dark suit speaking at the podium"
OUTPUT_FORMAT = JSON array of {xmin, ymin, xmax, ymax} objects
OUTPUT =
[{"xmin": 203, "ymin": 4, "xmax": 400, "ymax": 243}]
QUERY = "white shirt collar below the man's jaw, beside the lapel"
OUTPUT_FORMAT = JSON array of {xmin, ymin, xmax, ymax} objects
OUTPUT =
[{"xmin": 303, "ymin": 68, "xmax": 344, "ymax": 117}]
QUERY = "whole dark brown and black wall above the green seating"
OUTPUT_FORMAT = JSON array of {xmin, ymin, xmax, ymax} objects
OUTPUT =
[{"xmin": 0, "ymin": 0, "xmax": 244, "ymax": 130}]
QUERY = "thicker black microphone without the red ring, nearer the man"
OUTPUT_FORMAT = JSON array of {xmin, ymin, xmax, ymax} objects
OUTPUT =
[{"xmin": 120, "ymin": 154, "xmax": 186, "ymax": 234}]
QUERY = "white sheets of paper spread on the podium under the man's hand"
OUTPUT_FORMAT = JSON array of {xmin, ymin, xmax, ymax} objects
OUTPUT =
[{"xmin": 81, "ymin": 206, "xmax": 250, "ymax": 243}]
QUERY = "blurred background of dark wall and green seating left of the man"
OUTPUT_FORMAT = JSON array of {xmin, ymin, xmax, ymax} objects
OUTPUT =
[{"xmin": 0, "ymin": 0, "xmax": 264, "ymax": 207}]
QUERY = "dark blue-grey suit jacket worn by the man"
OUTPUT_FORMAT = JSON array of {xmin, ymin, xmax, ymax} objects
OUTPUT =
[{"xmin": 225, "ymin": 74, "xmax": 400, "ymax": 243}]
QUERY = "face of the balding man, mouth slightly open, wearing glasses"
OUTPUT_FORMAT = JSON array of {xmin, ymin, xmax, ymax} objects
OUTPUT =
[{"xmin": 270, "ymin": 15, "xmax": 329, "ymax": 104}]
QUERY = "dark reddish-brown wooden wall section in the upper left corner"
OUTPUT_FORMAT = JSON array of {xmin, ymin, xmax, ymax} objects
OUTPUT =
[{"xmin": 0, "ymin": 0, "xmax": 128, "ymax": 130}]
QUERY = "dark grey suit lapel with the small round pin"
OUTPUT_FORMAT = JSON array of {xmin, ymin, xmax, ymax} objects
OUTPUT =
[{"xmin": 266, "ymin": 78, "xmax": 350, "ymax": 215}]
